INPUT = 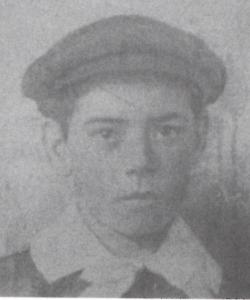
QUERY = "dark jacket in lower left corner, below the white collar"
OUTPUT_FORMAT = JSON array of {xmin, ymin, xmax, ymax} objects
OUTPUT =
[{"xmin": 0, "ymin": 251, "xmax": 88, "ymax": 297}]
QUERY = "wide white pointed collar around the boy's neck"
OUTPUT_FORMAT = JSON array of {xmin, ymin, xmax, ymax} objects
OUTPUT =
[{"xmin": 31, "ymin": 207, "xmax": 222, "ymax": 298}]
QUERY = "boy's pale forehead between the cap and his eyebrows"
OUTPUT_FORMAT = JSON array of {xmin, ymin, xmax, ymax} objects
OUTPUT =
[{"xmin": 75, "ymin": 82, "xmax": 191, "ymax": 119}]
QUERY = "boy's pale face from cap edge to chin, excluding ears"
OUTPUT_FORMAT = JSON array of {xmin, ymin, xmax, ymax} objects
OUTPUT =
[{"xmin": 65, "ymin": 79, "xmax": 205, "ymax": 238}]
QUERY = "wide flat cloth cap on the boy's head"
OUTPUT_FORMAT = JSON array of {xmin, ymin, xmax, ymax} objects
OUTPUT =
[{"xmin": 22, "ymin": 15, "xmax": 226, "ymax": 107}]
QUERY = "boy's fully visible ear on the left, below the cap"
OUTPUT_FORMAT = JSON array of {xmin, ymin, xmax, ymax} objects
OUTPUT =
[{"xmin": 42, "ymin": 120, "xmax": 71, "ymax": 176}]
